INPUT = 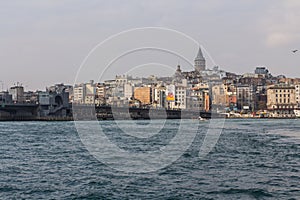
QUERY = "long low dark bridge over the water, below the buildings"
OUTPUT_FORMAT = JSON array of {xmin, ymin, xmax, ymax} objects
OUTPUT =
[{"xmin": 0, "ymin": 104, "xmax": 216, "ymax": 121}]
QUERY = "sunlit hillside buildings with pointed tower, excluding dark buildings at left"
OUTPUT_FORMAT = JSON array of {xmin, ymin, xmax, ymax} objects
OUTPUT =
[{"xmin": 59, "ymin": 48, "xmax": 300, "ymax": 117}]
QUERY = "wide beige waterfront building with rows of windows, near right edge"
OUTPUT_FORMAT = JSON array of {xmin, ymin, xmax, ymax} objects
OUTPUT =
[{"xmin": 267, "ymin": 84, "xmax": 297, "ymax": 118}]
